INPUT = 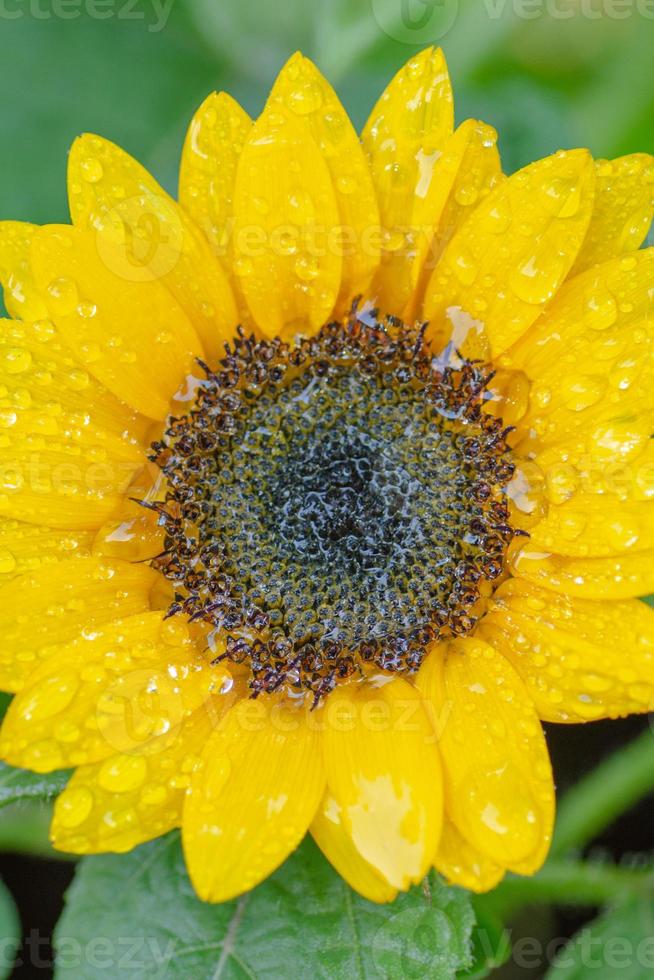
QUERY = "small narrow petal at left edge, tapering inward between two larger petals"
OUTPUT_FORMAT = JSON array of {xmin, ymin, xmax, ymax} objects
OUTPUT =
[{"xmin": 0, "ymin": 519, "xmax": 95, "ymax": 586}]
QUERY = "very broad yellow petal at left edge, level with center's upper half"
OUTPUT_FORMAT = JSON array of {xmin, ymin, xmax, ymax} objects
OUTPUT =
[{"xmin": 0, "ymin": 320, "xmax": 147, "ymax": 529}]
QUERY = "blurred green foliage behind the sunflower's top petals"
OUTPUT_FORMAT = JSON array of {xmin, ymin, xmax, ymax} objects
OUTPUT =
[{"xmin": 0, "ymin": 0, "xmax": 654, "ymax": 221}]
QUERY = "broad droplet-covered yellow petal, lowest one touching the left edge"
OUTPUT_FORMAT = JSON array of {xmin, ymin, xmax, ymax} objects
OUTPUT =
[{"xmin": 0, "ymin": 612, "xmax": 228, "ymax": 772}]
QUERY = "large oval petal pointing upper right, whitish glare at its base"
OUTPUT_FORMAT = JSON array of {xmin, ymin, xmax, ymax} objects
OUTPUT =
[{"xmin": 423, "ymin": 150, "xmax": 594, "ymax": 356}]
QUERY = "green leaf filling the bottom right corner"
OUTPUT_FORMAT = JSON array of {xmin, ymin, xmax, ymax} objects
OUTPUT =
[{"xmin": 547, "ymin": 887, "xmax": 654, "ymax": 980}]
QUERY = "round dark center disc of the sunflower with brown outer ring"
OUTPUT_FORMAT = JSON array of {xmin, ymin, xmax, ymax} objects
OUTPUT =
[{"xmin": 153, "ymin": 308, "xmax": 514, "ymax": 703}]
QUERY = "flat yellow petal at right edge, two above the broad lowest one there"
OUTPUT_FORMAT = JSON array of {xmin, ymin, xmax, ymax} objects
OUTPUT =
[{"xmin": 529, "ymin": 492, "xmax": 654, "ymax": 558}]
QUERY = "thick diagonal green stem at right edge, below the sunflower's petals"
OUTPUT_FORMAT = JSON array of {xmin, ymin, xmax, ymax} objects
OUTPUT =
[{"xmin": 550, "ymin": 730, "xmax": 654, "ymax": 857}]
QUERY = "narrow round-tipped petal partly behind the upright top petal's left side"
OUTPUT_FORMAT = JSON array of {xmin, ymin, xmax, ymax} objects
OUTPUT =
[{"xmin": 179, "ymin": 92, "xmax": 252, "ymax": 260}]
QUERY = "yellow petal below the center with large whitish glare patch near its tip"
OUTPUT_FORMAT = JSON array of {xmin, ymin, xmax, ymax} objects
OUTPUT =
[{"xmin": 324, "ymin": 678, "xmax": 443, "ymax": 891}]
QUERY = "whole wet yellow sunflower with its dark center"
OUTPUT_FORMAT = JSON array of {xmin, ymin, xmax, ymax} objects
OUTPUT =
[{"xmin": 0, "ymin": 49, "xmax": 654, "ymax": 902}]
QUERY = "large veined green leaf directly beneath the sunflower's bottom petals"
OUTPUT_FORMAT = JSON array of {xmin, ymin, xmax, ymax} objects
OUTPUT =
[{"xmin": 55, "ymin": 834, "xmax": 474, "ymax": 980}]
